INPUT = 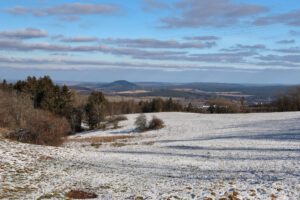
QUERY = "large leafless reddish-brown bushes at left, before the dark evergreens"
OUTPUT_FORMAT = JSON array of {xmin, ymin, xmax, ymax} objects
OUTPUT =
[{"xmin": 0, "ymin": 91, "xmax": 70, "ymax": 146}]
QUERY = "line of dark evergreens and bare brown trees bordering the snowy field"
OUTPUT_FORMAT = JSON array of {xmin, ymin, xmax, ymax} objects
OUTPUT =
[{"xmin": 0, "ymin": 76, "xmax": 300, "ymax": 143}]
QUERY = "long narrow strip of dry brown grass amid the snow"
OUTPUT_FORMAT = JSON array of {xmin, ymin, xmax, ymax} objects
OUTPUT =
[{"xmin": 69, "ymin": 135, "xmax": 134, "ymax": 144}]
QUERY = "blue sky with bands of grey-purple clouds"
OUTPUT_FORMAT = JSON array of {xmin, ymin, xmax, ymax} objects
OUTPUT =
[{"xmin": 0, "ymin": 0, "xmax": 300, "ymax": 84}]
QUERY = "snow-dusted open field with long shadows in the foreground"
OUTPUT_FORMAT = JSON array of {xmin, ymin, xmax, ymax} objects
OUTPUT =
[{"xmin": 0, "ymin": 112, "xmax": 300, "ymax": 199}]
